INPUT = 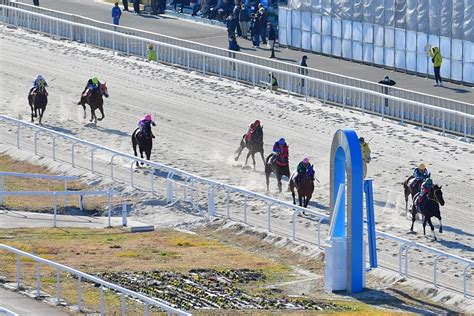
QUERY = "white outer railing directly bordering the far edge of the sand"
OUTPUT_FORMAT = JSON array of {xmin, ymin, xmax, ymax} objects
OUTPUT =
[{"xmin": 0, "ymin": 6, "xmax": 474, "ymax": 139}]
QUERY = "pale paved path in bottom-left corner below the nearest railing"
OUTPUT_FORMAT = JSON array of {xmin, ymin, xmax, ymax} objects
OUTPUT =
[{"xmin": 0, "ymin": 288, "xmax": 69, "ymax": 316}]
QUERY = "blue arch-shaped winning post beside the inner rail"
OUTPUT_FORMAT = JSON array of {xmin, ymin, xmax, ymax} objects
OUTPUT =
[{"xmin": 329, "ymin": 129, "xmax": 365, "ymax": 293}]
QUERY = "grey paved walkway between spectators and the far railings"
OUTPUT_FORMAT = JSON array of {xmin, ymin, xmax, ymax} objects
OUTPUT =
[{"xmin": 14, "ymin": 0, "xmax": 474, "ymax": 103}]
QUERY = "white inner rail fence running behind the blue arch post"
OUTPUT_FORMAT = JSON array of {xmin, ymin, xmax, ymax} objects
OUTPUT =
[{"xmin": 0, "ymin": 115, "xmax": 474, "ymax": 297}]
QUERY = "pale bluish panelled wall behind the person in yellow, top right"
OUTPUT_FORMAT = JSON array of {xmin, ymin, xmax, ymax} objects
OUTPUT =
[{"xmin": 278, "ymin": 0, "xmax": 474, "ymax": 85}]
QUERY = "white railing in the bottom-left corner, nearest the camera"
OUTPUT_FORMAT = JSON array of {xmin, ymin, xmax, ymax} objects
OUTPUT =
[{"xmin": 0, "ymin": 244, "xmax": 191, "ymax": 315}]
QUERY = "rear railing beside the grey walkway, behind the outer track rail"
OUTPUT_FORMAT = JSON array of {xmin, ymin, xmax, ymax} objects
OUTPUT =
[{"xmin": 4, "ymin": 0, "xmax": 474, "ymax": 118}]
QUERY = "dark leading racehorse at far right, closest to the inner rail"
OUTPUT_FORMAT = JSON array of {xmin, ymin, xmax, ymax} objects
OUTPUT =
[{"xmin": 410, "ymin": 184, "xmax": 444, "ymax": 240}]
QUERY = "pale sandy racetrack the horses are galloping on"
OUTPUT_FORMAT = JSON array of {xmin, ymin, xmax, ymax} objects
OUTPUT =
[{"xmin": 0, "ymin": 27, "xmax": 474, "ymax": 302}]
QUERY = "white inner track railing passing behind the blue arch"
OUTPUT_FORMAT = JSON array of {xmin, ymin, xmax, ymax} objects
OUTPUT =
[{"xmin": 0, "ymin": 115, "xmax": 474, "ymax": 296}]
